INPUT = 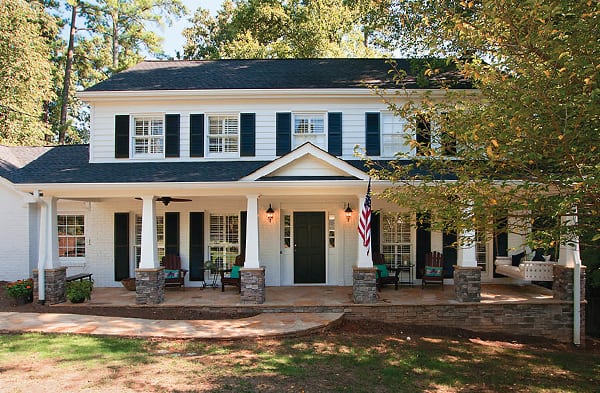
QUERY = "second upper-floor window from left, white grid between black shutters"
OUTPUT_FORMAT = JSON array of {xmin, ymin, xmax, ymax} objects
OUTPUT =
[{"xmin": 207, "ymin": 114, "xmax": 240, "ymax": 156}]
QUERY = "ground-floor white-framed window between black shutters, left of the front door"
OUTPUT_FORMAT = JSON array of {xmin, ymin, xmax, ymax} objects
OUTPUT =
[{"xmin": 206, "ymin": 212, "xmax": 242, "ymax": 269}]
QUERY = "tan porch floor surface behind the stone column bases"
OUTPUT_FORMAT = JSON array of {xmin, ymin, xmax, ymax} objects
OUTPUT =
[{"xmin": 61, "ymin": 284, "xmax": 554, "ymax": 310}]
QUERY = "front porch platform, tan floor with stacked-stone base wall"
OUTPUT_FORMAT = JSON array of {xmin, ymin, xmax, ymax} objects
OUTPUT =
[{"xmin": 50, "ymin": 284, "xmax": 585, "ymax": 342}]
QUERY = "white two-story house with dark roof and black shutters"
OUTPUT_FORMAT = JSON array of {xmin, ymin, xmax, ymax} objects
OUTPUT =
[{"xmin": 0, "ymin": 59, "xmax": 522, "ymax": 304}]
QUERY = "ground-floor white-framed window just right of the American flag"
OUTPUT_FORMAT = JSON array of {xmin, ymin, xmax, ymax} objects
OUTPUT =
[{"xmin": 379, "ymin": 212, "xmax": 415, "ymax": 268}]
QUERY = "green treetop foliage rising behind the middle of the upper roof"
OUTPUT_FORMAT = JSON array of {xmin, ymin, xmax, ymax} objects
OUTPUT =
[{"xmin": 183, "ymin": 0, "xmax": 389, "ymax": 59}]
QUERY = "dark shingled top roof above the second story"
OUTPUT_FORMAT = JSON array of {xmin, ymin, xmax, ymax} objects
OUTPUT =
[{"xmin": 86, "ymin": 59, "xmax": 468, "ymax": 92}]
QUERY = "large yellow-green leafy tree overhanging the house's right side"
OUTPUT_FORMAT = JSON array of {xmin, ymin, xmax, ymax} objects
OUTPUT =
[{"xmin": 373, "ymin": 0, "xmax": 600, "ymax": 258}]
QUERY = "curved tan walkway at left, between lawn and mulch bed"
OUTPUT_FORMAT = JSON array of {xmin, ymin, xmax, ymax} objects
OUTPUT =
[{"xmin": 0, "ymin": 312, "xmax": 343, "ymax": 340}]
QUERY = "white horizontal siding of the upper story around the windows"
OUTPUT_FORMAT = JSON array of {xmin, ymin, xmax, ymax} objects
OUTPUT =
[{"xmin": 90, "ymin": 96, "xmax": 396, "ymax": 162}]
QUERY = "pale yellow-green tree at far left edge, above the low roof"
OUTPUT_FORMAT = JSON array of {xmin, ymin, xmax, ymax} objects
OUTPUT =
[{"xmin": 0, "ymin": 0, "xmax": 58, "ymax": 145}]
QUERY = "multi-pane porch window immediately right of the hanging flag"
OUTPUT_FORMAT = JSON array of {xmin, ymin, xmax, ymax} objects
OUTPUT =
[{"xmin": 381, "ymin": 212, "xmax": 412, "ymax": 268}]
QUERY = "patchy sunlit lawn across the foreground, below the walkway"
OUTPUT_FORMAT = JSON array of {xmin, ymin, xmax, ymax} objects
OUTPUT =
[{"xmin": 0, "ymin": 332, "xmax": 600, "ymax": 393}]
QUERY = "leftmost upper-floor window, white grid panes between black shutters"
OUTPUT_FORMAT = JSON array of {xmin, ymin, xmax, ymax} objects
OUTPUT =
[{"xmin": 132, "ymin": 116, "xmax": 165, "ymax": 158}]
